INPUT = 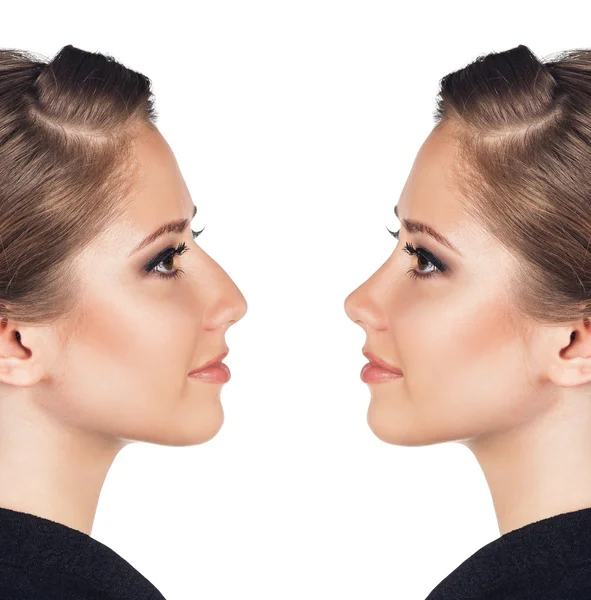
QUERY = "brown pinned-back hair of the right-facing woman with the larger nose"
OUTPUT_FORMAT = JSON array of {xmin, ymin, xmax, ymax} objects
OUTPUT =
[{"xmin": 0, "ymin": 45, "xmax": 156, "ymax": 338}]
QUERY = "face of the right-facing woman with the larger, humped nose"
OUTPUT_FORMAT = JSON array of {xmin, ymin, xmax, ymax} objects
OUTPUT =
[{"xmin": 26, "ymin": 122, "xmax": 246, "ymax": 446}]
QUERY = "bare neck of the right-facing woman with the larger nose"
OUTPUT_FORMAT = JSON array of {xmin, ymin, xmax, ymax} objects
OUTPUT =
[{"xmin": 0, "ymin": 395, "xmax": 126, "ymax": 535}]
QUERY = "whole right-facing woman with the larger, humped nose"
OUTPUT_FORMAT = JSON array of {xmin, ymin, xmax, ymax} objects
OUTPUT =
[{"xmin": 0, "ymin": 45, "xmax": 247, "ymax": 600}]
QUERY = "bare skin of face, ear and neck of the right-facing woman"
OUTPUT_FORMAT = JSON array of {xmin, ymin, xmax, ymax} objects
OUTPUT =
[{"xmin": 0, "ymin": 124, "xmax": 247, "ymax": 535}]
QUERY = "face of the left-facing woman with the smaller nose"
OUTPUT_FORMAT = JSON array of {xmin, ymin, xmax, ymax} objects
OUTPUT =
[{"xmin": 345, "ymin": 124, "xmax": 552, "ymax": 446}]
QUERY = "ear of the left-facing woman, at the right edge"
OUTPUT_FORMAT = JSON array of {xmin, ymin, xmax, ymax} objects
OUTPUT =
[{"xmin": 547, "ymin": 318, "xmax": 591, "ymax": 387}]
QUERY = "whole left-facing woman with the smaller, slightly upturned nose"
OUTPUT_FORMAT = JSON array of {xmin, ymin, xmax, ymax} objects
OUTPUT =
[{"xmin": 345, "ymin": 45, "xmax": 591, "ymax": 600}]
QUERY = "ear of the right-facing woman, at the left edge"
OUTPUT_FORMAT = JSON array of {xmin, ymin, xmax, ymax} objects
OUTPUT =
[{"xmin": 0, "ymin": 318, "xmax": 58, "ymax": 387}]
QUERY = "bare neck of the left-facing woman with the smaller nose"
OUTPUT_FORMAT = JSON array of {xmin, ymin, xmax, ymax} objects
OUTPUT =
[{"xmin": 462, "ymin": 394, "xmax": 591, "ymax": 535}]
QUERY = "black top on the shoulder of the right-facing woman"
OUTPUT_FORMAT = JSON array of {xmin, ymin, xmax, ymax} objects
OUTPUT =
[{"xmin": 0, "ymin": 507, "xmax": 165, "ymax": 600}]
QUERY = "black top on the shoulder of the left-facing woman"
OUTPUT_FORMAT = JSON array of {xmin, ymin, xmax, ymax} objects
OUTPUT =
[{"xmin": 426, "ymin": 508, "xmax": 591, "ymax": 600}]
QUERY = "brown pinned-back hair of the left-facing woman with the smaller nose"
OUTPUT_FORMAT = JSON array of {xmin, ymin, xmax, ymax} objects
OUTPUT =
[{"xmin": 435, "ymin": 45, "xmax": 591, "ymax": 324}]
